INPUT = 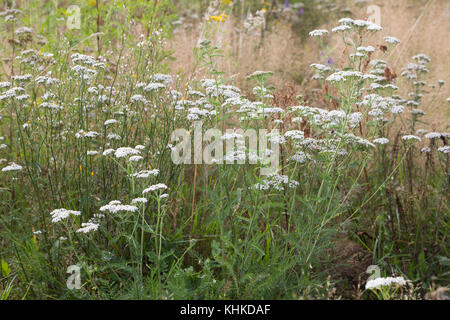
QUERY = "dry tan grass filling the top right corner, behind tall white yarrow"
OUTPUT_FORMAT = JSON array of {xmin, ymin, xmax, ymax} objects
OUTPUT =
[{"xmin": 346, "ymin": 0, "xmax": 450, "ymax": 130}]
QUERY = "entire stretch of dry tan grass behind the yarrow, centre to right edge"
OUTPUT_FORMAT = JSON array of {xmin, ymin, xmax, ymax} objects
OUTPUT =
[{"xmin": 169, "ymin": 0, "xmax": 450, "ymax": 130}]
